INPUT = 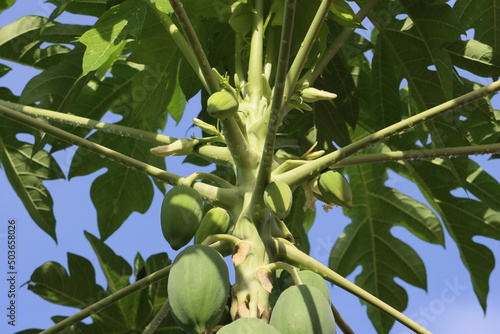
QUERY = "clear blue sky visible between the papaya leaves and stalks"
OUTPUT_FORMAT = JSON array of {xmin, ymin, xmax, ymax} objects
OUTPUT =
[{"xmin": 0, "ymin": 0, "xmax": 500, "ymax": 334}]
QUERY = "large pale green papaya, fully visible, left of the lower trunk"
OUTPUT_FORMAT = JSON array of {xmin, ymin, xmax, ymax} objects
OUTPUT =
[{"xmin": 167, "ymin": 245, "xmax": 229, "ymax": 334}]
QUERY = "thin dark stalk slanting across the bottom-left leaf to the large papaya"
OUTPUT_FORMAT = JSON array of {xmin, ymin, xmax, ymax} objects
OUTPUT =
[{"xmin": 40, "ymin": 265, "xmax": 172, "ymax": 334}]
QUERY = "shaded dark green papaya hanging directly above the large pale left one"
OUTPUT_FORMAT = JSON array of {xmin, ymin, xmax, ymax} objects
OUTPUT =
[{"xmin": 161, "ymin": 185, "xmax": 203, "ymax": 250}]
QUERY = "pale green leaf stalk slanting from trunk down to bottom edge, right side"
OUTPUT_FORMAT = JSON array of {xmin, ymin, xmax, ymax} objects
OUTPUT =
[{"xmin": 273, "ymin": 240, "xmax": 431, "ymax": 334}]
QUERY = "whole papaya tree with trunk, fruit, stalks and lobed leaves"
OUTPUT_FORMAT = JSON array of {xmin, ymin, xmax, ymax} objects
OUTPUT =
[{"xmin": 0, "ymin": 0, "xmax": 500, "ymax": 334}]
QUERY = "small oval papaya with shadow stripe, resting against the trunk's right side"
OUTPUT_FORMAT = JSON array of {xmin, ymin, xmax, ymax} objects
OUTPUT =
[{"xmin": 264, "ymin": 180, "xmax": 293, "ymax": 220}]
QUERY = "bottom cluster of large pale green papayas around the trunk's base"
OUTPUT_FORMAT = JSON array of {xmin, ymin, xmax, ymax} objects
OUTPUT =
[{"xmin": 168, "ymin": 245, "xmax": 335, "ymax": 334}]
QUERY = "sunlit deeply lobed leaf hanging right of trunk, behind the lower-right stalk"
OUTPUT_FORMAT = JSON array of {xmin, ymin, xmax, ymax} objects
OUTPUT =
[{"xmin": 329, "ymin": 161, "xmax": 444, "ymax": 333}]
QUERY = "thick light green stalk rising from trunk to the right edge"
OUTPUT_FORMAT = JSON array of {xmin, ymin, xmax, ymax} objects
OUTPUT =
[{"xmin": 276, "ymin": 80, "xmax": 500, "ymax": 187}]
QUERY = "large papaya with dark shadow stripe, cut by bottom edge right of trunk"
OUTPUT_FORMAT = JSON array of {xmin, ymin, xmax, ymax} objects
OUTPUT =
[{"xmin": 269, "ymin": 284, "xmax": 336, "ymax": 334}]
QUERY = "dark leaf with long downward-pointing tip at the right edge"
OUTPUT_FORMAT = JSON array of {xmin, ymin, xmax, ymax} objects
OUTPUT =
[{"xmin": 405, "ymin": 159, "xmax": 500, "ymax": 310}]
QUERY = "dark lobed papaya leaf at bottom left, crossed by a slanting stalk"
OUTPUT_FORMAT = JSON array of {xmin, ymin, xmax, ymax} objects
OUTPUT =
[{"xmin": 26, "ymin": 244, "xmax": 182, "ymax": 334}]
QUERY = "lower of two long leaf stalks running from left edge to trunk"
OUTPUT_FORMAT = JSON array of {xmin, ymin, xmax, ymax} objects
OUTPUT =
[{"xmin": 0, "ymin": 105, "xmax": 236, "ymax": 207}]
